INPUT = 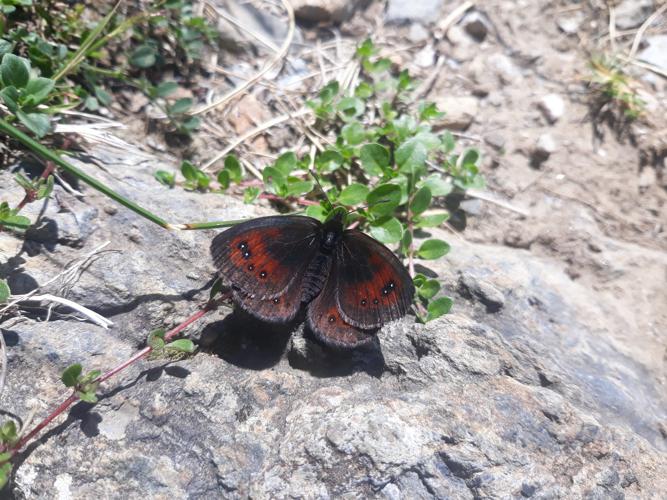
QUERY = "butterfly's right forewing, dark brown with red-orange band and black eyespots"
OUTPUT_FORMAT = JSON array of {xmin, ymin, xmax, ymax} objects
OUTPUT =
[{"xmin": 336, "ymin": 230, "xmax": 415, "ymax": 328}]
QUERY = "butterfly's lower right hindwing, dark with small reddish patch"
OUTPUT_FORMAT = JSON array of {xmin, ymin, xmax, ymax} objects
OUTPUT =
[{"xmin": 307, "ymin": 262, "xmax": 376, "ymax": 349}]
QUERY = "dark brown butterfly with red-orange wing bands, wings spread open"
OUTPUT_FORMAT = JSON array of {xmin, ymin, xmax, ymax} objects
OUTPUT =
[{"xmin": 211, "ymin": 211, "xmax": 415, "ymax": 348}]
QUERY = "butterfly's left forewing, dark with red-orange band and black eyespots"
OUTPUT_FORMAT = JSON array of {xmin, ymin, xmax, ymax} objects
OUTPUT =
[{"xmin": 211, "ymin": 216, "xmax": 321, "ymax": 298}]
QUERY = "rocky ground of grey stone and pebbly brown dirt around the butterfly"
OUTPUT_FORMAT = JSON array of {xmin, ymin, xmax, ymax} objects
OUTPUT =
[{"xmin": 0, "ymin": 0, "xmax": 667, "ymax": 499}]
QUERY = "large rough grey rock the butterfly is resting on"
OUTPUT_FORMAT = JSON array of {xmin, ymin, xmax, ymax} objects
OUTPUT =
[{"xmin": 0, "ymin": 146, "xmax": 667, "ymax": 499}]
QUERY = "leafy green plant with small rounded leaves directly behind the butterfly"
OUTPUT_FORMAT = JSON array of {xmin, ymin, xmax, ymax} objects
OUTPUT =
[{"xmin": 190, "ymin": 40, "xmax": 484, "ymax": 321}]
